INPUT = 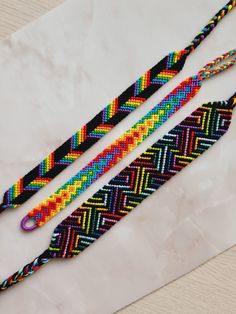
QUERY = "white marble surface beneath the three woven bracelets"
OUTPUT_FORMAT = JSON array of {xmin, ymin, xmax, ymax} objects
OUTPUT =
[{"xmin": 0, "ymin": 0, "xmax": 236, "ymax": 314}]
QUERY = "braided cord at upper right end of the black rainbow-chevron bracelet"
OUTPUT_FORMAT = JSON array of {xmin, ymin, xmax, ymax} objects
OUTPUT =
[{"xmin": 185, "ymin": 0, "xmax": 236, "ymax": 54}]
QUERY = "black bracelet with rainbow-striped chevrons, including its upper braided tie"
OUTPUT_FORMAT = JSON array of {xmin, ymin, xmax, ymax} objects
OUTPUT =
[{"xmin": 0, "ymin": 0, "xmax": 236, "ymax": 212}]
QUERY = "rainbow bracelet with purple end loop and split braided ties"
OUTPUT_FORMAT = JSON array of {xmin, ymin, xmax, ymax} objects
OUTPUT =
[{"xmin": 21, "ymin": 49, "xmax": 236, "ymax": 231}]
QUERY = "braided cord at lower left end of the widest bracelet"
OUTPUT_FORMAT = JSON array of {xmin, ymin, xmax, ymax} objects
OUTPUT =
[{"xmin": 0, "ymin": 250, "xmax": 51, "ymax": 292}]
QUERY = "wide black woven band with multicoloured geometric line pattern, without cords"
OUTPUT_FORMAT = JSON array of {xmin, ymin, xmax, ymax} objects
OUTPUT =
[{"xmin": 49, "ymin": 101, "xmax": 233, "ymax": 258}]
